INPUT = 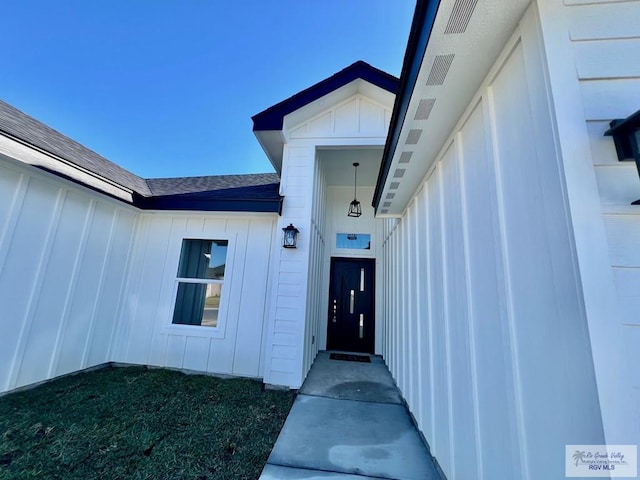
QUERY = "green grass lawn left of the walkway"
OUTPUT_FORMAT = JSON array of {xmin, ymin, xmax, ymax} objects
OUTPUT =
[{"xmin": 0, "ymin": 367, "xmax": 293, "ymax": 480}]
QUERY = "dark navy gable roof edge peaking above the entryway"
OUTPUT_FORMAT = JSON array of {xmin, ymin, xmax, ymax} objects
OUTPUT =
[{"xmin": 251, "ymin": 60, "xmax": 398, "ymax": 132}]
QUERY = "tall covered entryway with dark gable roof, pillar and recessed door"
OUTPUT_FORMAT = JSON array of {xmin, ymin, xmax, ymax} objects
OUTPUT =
[{"xmin": 253, "ymin": 62, "xmax": 398, "ymax": 388}]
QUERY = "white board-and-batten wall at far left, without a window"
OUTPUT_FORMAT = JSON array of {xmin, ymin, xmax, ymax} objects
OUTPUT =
[{"xmin": 0, "ymin": 158, "xmax": 137, "ymax": 391}]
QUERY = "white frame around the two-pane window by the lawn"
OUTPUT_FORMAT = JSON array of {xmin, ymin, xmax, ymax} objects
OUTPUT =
[{"xmin": 167, "ymin": 234, "xmax": 235, "ymax": 338}]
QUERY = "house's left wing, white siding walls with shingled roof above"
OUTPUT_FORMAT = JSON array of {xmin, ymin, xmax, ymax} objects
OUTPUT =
[{"xmin": 0, "ymin": 98, "xmax": 281, "ymax": 391}]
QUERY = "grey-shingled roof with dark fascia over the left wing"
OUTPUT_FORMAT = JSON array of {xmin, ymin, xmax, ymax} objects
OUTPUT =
[{"xmin": 0, "ymin": 100, "xmax": 282, "ymax": 213}]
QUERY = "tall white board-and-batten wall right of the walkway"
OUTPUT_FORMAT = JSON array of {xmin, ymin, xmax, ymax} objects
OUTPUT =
[{"xmin": 383, "ymin": 6, "xmax": 604, "ymax": 480}]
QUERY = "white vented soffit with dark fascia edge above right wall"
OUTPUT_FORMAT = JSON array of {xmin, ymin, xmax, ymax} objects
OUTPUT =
[{"xmin": 373, "ymin": 0, "xmax": 531, "ymax": 216}]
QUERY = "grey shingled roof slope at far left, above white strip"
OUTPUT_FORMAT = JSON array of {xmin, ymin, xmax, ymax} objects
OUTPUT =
[{"xmin": 0, "ymin": 100, "xmax": 151, "ymax": 196}]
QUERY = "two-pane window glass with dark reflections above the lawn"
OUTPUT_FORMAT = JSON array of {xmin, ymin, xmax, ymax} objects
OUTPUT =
[{"xmin": 173, "ymin": 239, "xmax": 229, "ymax": 327}]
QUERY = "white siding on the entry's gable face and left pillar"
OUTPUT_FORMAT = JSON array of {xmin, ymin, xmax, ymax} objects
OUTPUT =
[{"xmin": 264, "ymin": 91, "xmax": 393, "ymax": 388}]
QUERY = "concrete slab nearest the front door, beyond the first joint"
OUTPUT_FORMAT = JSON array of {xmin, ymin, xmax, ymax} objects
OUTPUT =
[{"xmin": 300, "ymin": 352, "xmax": 402, "ymax": 403}]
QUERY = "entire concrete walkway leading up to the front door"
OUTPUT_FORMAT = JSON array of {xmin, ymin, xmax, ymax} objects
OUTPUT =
[{"xmin": 260, "ymin": 352, "xmax": 441, "ymax": 480}]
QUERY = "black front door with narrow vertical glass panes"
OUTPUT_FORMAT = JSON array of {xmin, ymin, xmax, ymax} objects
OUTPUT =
[{"xmin": 327, "ymin": 258, "xmax": 375, "ymax": 353}]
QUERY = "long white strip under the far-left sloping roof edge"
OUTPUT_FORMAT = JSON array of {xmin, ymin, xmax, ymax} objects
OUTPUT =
[{"xmin": 0, "ymin": 133, "xmax": 133, "ymax": 204}]
